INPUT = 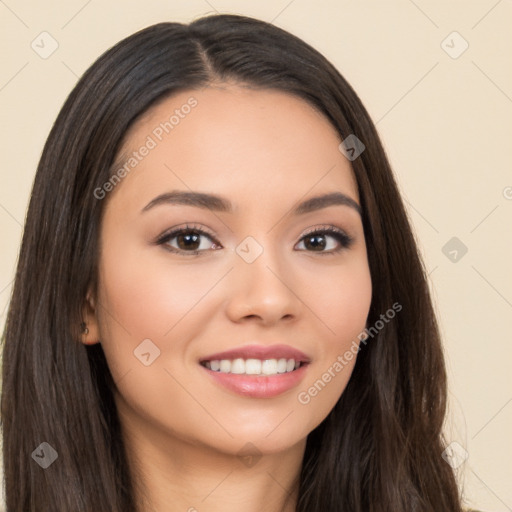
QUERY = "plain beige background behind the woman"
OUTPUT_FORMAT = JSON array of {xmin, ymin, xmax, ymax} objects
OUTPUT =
[{"xmin": 0, "ymin": 0, "xmax": 512, "ymax": 512}]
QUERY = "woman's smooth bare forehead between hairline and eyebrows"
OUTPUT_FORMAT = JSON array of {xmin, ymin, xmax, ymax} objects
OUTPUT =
[{"xmin": 106, "ymin": 85, "xmax": 358, "ymax": 213}]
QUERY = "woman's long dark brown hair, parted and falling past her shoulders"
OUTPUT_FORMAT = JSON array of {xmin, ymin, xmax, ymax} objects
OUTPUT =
[{"xmin": 1, "ymin": 15, "xmax": 461, "ymax": 512}]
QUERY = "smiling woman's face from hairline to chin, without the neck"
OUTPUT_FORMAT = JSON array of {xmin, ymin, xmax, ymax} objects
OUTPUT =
[{"xmin": 86, "ymin": 85, "xmax": 372, "ymax": 454}]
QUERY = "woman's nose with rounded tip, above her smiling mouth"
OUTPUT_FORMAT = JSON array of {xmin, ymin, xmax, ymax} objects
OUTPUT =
[{"xmin": 226, "ymin": 249, "xmax": 304, "ymax": 325}]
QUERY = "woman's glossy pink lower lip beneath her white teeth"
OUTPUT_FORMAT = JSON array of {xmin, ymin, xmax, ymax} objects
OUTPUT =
[{"xmin": 201, "ymin": 364, "xmax": 309, "ymax": 398}]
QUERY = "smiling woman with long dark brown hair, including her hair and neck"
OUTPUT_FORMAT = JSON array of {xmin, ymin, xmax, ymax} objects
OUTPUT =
[{"xmin": 1, "ymin": 15, "xmax": 470, "ymax": 512}]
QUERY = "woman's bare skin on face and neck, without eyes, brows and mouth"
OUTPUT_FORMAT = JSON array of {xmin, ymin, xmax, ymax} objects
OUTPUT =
[{"xmin": 83, "ymin": 84, "xmax": 372, "ymax": 512}]
